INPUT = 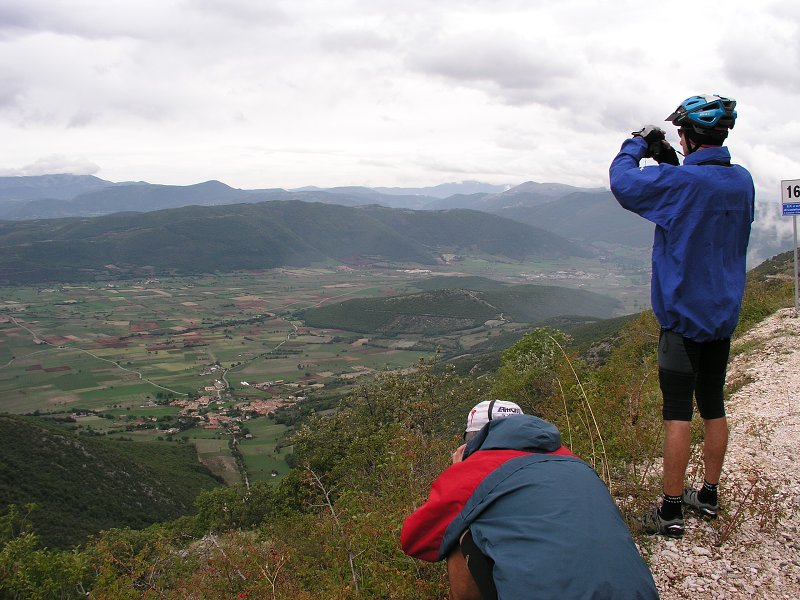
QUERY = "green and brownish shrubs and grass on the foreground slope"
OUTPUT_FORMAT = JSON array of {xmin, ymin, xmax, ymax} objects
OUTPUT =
[{"xmin": 0, "ymin": 255, "xmax": 793, "ymax": 600}]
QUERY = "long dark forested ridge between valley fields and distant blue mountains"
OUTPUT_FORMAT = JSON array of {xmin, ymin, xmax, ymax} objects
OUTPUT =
[{"xmin": 0, "ymin": 201, "xmax": 588, "ymax": 284}]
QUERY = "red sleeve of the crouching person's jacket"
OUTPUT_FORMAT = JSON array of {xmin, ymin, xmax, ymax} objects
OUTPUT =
[{"xmin": 400, "ymin": 450, "xmax": 529, "ymax": 562}]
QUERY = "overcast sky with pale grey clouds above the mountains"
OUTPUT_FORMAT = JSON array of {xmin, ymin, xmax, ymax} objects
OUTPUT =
[{"xmin": 0, "ymin": 0, "xmax": 800, "ymax": 206}]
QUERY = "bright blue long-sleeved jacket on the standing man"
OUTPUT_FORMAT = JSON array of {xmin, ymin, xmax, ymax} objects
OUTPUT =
[{"xmin": 610, "ymin": 137, "xmax": 755, "ymax": 342}]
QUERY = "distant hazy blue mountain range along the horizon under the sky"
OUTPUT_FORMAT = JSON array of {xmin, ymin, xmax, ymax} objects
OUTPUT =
[{"xmin": 0, "ymin": 175, "xmax": 788, "ymax": 274}]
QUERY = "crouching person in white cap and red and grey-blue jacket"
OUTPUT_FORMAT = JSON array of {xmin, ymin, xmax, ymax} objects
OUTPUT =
[{"xmin": 401, "ymin": 400, "xmax": 658, "ymax": 600}]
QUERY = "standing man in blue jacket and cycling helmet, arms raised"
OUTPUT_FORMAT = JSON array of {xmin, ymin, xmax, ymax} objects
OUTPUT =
[{"xmin": 610, "ymin": 95, "xmax": 755, "ymax": 537}]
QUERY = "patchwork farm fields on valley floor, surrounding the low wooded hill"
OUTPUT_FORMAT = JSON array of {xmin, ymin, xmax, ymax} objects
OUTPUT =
[{"xmin": 0, "ymin": 259, "xmax": 646, "ymax": 482}]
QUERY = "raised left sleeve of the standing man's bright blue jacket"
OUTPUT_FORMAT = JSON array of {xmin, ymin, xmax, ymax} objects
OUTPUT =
[{"xmin": 609, "ymin": 137, "xmax": 681, "ymax": 229}]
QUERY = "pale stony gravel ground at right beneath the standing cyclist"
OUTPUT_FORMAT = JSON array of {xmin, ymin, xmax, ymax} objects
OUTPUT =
[{"xmin": 647, "ymin": 309, "xmax": 800, "ymax": 600}]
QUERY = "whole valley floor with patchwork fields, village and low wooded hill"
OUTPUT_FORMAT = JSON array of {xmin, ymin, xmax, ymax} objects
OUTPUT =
[{"xmin": 0, "ymin": 258, "xmax": 644, "ymax": 490}]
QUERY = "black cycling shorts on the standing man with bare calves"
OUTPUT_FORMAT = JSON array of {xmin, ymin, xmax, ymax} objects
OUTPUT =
[{"xmin": 658, "ymin": 330, "xmax": 731, "ymax": 421}]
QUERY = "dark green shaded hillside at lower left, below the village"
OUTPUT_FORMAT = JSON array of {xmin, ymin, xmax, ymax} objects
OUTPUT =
[{"xmin": 0, "ymin": 415, "xmax": 219, "ymax": 548}]
